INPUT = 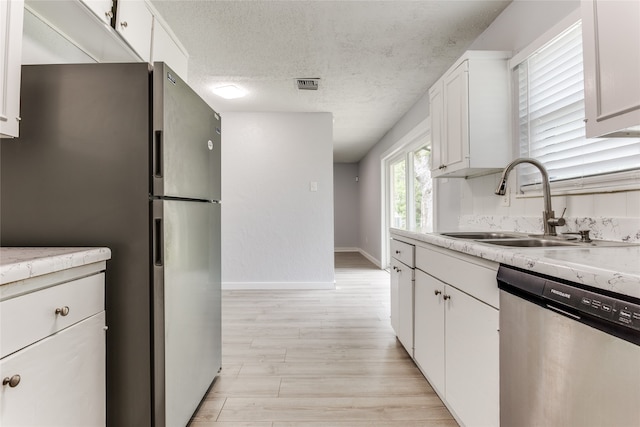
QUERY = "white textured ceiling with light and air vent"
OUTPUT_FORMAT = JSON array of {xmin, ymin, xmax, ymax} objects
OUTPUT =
[{"xmin": 152, "ymin": 0, "xmax": 510, "ymax": 162}]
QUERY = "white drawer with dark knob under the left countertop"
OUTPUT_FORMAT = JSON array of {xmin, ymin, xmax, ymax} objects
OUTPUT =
[{"xmin": 0, "ymin": 273, "xmax": 104, "ymax": 357}]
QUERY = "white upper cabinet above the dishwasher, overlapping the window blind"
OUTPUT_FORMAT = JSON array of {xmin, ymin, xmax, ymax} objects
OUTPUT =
[{"xmin": 582, "ymin": 0, "xmax": 640, "ymax": 138}]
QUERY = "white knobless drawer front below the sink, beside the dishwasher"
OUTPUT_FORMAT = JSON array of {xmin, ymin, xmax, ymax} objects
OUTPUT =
[{"xmin": 416, "ymin": 246, "xmax": 499, "ymax": 308}]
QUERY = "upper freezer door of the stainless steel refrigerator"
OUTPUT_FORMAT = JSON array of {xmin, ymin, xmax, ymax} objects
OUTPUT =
[{"xmin": 152, "ymin": 62, "xmax": 221, "ymax": 200}]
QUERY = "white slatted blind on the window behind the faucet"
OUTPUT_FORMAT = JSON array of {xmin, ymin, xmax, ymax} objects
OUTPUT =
[{"xmin": 514, "ymin": 23, "xmax": 640, "ymax": 186}]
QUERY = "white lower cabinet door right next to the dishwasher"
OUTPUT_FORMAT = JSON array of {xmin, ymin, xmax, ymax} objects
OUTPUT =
[{"xmin": 445, "ymin": 286, "xmax": 500, "ymax": 426}]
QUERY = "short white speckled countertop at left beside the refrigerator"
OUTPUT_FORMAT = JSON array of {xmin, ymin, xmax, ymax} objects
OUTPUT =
[{"xmin": 0, "ymin": 248, "xmax": 111, "ymax": 285}]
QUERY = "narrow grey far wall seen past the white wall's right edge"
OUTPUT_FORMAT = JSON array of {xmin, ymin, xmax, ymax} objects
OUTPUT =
[{"xmin": 333, "ymin": 163, "xmax": 360, "ymax": 251}]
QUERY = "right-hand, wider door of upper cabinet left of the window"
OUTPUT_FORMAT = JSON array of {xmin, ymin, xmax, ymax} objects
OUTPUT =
[{"xmin": 444, "ymin": 61, "xmax": 469, "ymax": 173}]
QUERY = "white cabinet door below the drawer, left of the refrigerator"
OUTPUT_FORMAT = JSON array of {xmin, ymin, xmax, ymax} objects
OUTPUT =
[{"xmin": 0, "ymin": 311, "xmax": 106, "ymax": 427}]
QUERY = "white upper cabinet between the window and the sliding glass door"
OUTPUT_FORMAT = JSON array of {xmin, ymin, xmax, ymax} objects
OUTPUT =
[{"xmin": 429, "ymin": 51, "xmax": 511, "ymax": 177}]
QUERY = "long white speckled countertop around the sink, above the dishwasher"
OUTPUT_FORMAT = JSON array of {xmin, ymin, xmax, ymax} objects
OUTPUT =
[{"xmin": 391, "ymin": 229, "xmax": 640, "ymax": 298}]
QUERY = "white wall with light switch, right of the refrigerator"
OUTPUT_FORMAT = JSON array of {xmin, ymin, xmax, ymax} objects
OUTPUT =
[{"xmin": 222, "ymin": 113, "xmax": 334, "ymax": 289}]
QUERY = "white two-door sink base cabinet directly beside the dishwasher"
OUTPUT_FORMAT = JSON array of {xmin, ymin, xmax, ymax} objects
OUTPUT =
[{"xmin": 414, "ymin": 246, "xmax": 500, "ymax": 427}]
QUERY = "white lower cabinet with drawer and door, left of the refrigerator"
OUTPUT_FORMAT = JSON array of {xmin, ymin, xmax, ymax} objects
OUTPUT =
[{"xmin": 0, "ymin": 266, "xmax": 106, "ymax": 427}]
